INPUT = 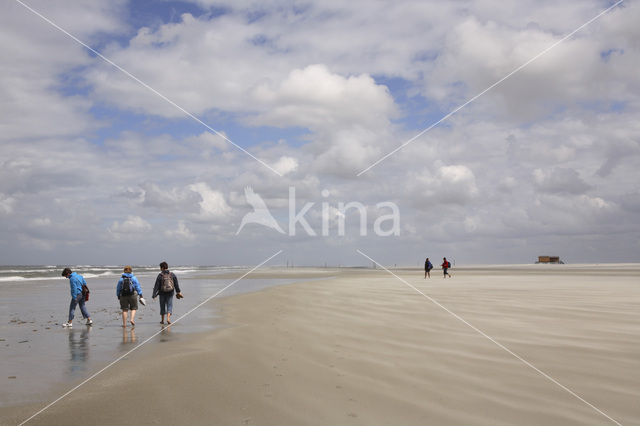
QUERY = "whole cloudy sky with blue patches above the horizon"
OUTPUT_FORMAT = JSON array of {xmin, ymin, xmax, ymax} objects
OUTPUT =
[{"xmin": 0, "ymin": 0, "xmax": 640, "ymax": 266}]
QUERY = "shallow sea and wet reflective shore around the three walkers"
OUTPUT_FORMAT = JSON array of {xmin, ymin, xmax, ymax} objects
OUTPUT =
[{"xmin": 0, "ymin": 265, "xmax": 299, "ymax": 406}]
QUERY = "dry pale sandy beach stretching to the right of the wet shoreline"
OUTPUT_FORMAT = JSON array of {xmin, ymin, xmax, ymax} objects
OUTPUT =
[{"xmin": 0, "ymin": 264, "xmax": 640, "ymax": 425}]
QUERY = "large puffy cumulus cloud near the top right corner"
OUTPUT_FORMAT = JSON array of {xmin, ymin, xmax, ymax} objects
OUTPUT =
[{"xmin": 425, "ymin": 5, "xmax": 638, "ymax": 120}]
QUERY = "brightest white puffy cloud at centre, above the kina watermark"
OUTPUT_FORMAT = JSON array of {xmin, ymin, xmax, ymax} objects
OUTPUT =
[{"xmin": 251, "ymin": 64, "xmax": 397, "ymax": 176}]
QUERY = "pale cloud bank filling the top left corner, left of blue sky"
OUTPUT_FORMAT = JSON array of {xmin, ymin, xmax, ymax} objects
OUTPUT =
[{"xmin": 0, "ymin": 1, "xmax": 125, "ymax": 141}]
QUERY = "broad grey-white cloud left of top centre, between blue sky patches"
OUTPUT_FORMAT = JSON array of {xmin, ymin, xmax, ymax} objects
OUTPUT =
[{"xmin": 87, "ymin": 14, "xmax": 279, "ymax": 118}]
